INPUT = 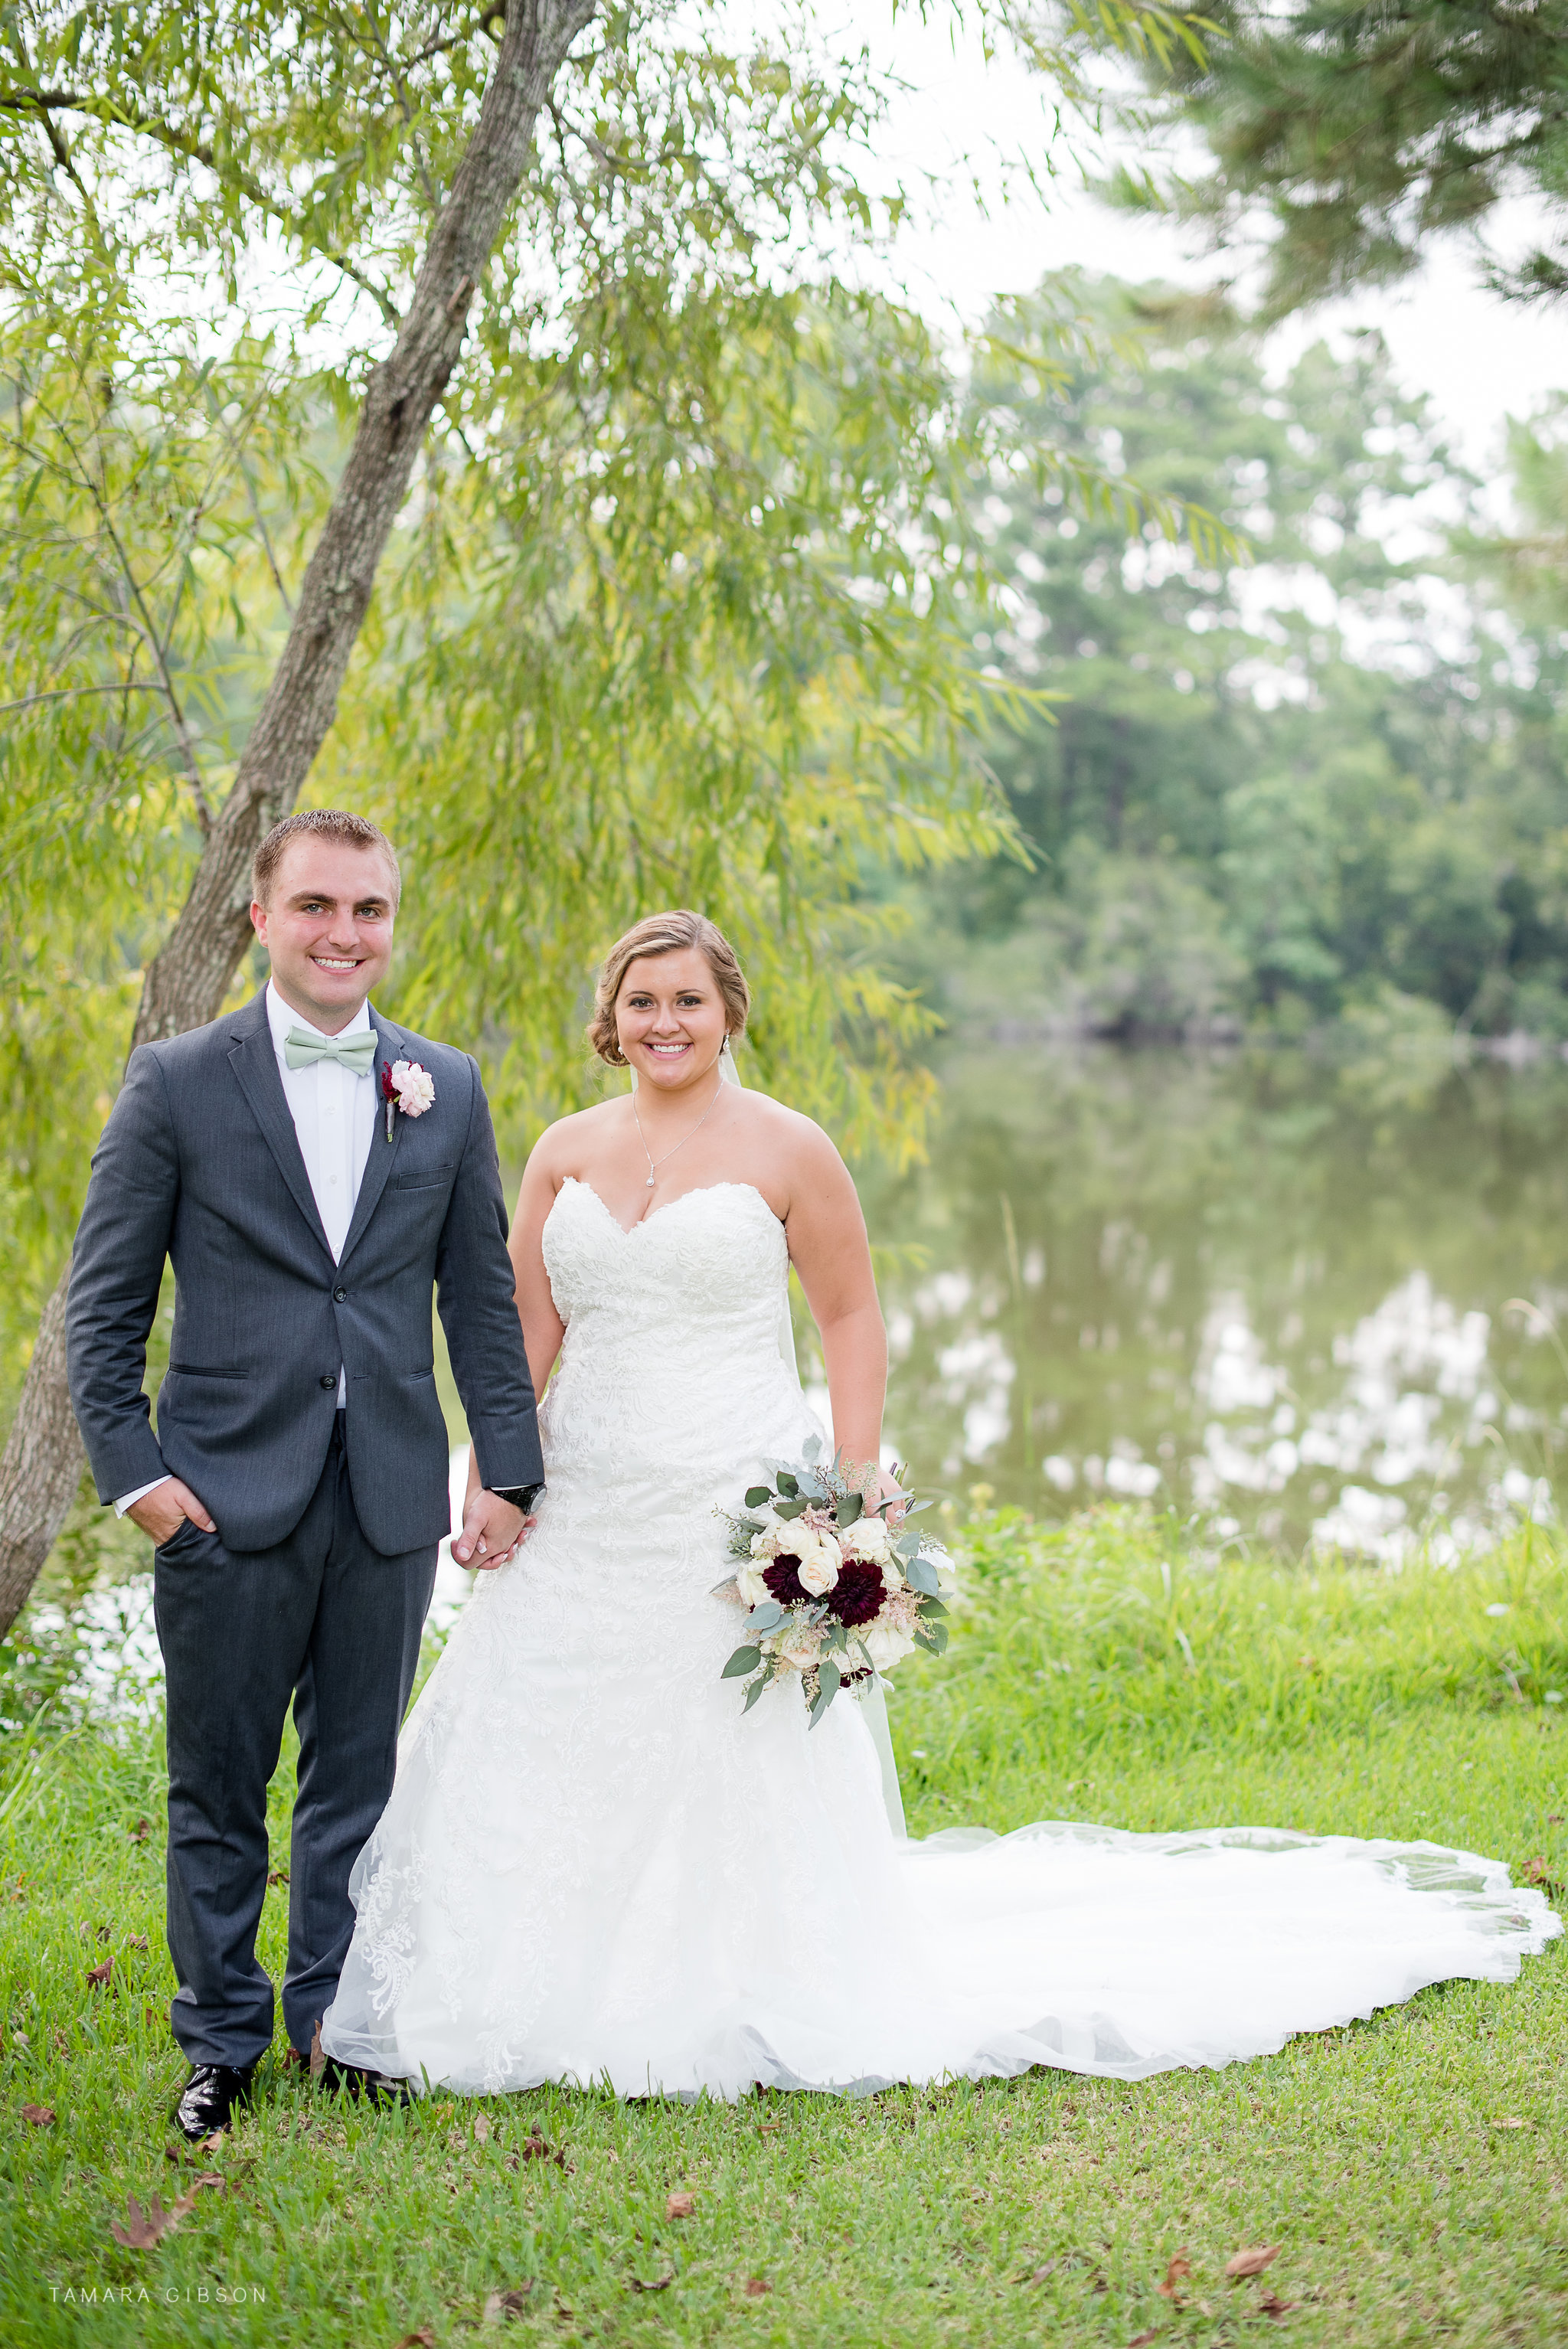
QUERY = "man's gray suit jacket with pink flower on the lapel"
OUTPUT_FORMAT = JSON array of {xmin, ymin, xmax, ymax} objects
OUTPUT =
[{"xmin": 68, "ymin": 996, "xmax": 544, "ymax": 1557}]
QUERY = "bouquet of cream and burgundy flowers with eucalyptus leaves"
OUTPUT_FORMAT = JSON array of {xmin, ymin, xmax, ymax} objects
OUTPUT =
[{"xmin": 714, "ymin": 1438, "xmax": 953, "ymax": 1729}]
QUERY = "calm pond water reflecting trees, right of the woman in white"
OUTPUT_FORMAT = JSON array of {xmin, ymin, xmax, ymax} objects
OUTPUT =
[{"xmin": 840, "ymin": 1047, "xmax": 1568, "ymax": 1560}]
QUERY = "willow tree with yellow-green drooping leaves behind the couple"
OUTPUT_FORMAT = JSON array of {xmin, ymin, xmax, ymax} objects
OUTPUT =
[{"xmin": 0, "ymin": 0, "xmax": 1210, "ymax": 1628}]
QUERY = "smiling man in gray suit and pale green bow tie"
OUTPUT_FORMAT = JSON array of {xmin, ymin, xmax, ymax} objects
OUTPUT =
[{"xmin": 68, "ymin": 810, "xmax": 542, "ymax": 2140}]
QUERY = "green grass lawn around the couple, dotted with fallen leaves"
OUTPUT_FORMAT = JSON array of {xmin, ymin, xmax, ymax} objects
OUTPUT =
[{"xmin": 0, "ymin": 1513, "xmax": 1568, "ymax": 2349}]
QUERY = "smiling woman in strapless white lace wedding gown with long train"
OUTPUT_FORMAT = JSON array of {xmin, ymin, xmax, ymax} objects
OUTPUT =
[{"xmin": 322, "ymin": 913, "xmax": 1559, "ymax": 2098}]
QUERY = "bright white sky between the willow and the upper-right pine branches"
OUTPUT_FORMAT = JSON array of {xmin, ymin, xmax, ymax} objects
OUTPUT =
[{"xmin": 841, "ymin": 0, "xmax": 1568, "ymax": 486}]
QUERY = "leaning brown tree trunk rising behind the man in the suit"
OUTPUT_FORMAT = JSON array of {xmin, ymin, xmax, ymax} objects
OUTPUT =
[{"xmin": 0, "ymin": 0, "xmax": 596, "ymax": 1635}]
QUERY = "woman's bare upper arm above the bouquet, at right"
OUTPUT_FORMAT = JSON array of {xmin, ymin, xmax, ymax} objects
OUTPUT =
[{"xmin": 784, "ymin": 1120, "xmax": 887, "ymax": 1463}]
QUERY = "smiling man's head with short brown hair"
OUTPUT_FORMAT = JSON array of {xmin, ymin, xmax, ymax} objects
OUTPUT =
[{"xmin": 251, "ymin": 831, "xmax": 397, "ymax": 1036}]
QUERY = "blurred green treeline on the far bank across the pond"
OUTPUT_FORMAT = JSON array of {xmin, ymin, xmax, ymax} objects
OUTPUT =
[{"xmin": 906, "ymin": 277, "xmax": 1568, "ymax": 1041}]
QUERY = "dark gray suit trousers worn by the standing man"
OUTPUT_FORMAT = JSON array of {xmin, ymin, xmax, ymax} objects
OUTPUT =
[{"xmin": 152, "ymin": 1412, "xmax": 436, "ymax": 2065}]
